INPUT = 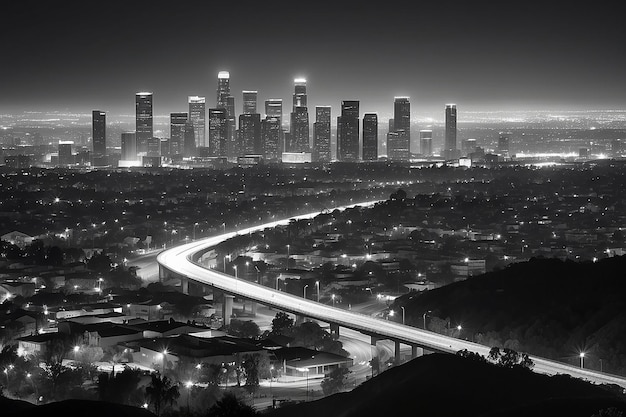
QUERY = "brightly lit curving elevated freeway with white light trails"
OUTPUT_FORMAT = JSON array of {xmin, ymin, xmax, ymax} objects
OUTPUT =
[{"xmin": 157, "ymin": 201, "xmax": 626, "ymax": 388}]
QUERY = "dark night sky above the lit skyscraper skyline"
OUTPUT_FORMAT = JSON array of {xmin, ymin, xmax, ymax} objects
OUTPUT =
[{"xmin": 0, "ymin": 0, "xmax": 626, "ymax": 115}]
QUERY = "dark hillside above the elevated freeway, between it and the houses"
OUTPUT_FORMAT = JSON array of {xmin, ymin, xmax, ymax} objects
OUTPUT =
[{"xmin": 391, "ymin": 256, "xmax": 626, "ymax": 375}]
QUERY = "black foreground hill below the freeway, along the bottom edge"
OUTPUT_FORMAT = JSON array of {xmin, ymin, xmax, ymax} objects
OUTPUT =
[{"xmin": 267, "ymin": 353, "xmax": 626, "ymax": 417}]
